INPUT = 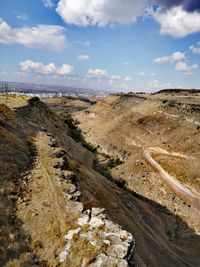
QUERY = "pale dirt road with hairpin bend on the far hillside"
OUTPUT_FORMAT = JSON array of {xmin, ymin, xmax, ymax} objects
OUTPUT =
[{"xmin": 144, "ymin": 147, "xmax": 200, "ymax": 210}]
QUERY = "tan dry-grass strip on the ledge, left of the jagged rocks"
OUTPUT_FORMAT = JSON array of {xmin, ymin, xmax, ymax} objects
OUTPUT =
[{"xmin": 18, "ymin": 133, "xmax": 80, "ymax": 266}]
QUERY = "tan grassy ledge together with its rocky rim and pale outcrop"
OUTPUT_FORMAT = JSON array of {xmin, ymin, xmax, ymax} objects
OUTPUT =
[{"xmin": 17, "ymin": 133, "xmax": 134, "ymax": 267}]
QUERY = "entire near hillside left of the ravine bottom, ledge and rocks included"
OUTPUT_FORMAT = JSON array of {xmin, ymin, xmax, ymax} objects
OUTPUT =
[{"xmin": 0, "ymin": 95, "xmax": 200, "ymax": 267}]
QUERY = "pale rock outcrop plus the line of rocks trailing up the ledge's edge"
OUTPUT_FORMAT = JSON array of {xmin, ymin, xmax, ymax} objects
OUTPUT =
[{"xmin": 50, "ymin": 139, "xmax": 135, "ymax": 267}]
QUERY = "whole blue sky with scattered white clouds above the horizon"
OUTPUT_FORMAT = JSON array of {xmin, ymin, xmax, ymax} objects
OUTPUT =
[{"xmin": 0, "ymin": 0, "xmax": 200, "ymax": 91}]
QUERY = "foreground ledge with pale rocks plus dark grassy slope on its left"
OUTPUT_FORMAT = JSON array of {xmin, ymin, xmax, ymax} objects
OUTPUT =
[{"xmin": 0, "ymin": 96, "xmax": 135, "ymax": 267}]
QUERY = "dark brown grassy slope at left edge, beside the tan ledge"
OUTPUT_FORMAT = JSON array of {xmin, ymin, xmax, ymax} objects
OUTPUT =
[{"xmin": 0, "ymin": 104, "xmax": 34, "ymax": 266}]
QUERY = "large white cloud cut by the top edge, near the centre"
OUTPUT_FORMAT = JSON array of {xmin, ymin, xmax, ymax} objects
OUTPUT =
[{"xmin": 56, "ymin": 0, "xmax": 147, "ymax": 27}]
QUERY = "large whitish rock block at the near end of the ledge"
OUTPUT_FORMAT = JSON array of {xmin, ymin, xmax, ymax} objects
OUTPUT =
[{"xmin": 60, "ymin": 208, "xmax": 134, "ymax": 267}]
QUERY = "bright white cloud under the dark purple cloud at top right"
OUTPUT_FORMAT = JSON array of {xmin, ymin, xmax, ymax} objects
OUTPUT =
[{"xmin": 153, "ymin": 6, "xmax": 200, "ymax": 38}]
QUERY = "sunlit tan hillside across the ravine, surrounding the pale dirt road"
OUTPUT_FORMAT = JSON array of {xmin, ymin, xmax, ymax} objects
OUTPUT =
[{"xmin": 75, "ymin": 92, "xmax": 200, "ymax": 232}]
